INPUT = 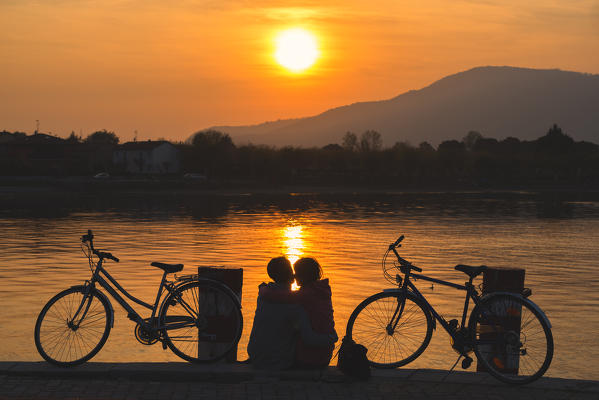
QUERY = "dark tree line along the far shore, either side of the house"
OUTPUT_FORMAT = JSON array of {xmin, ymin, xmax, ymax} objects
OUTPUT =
[{"xmin": 0, "ymin": 125, "xmax": 599, "ymax": 187}]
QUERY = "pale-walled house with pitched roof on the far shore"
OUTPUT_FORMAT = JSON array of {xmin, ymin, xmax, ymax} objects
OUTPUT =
[{"xmin": 112, "ymin": 140, "xmax": 181, "ymax": 174}]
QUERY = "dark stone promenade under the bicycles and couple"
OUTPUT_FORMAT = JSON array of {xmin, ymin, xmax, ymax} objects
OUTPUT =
[{"xmin": 0, "ymin": 362, "xmax": 599, "ymax": 400}]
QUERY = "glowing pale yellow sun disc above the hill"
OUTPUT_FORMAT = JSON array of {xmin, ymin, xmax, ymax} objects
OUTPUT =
[{"xmin": 275, "ymin": 28, "xmax": 319, "ymax": 73}]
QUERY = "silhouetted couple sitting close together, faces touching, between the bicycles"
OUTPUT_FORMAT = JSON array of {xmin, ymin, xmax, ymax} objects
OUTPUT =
[{"xmin": 248, "ymin": 257, "xmax": 338, "ymax": 370}]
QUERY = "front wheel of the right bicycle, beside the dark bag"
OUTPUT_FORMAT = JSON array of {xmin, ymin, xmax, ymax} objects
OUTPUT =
[{"xmin": 346, "ymin": 292, "xmax": 433, "ymax": 368}]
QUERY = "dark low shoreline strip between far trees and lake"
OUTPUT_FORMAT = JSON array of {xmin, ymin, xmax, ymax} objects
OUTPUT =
[{"xmin": 0, "ymin": 176, "xmax": 599, "ymax": 199}]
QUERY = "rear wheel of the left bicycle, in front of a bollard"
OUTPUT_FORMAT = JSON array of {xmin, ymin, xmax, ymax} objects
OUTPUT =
[{"xmin": 160, "ymin": 281, "xmax": 243, "ymax": 363}]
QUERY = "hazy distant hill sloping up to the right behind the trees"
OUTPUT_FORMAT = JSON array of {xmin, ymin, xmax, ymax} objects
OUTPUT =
[{"xmin": 205, "ymin": 67, "xmax": 599, "ymax": 146}]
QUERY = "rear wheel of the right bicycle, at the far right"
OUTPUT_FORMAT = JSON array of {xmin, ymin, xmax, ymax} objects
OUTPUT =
[{"xmin": 469, "ymin": 295, "xmax": 553, "ymax": 384}]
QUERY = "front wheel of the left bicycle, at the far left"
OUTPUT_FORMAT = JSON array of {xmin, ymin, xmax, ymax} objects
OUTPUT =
[{"xmin": 34, "ymin": 286, "xmax": 111, "ymax": 367}]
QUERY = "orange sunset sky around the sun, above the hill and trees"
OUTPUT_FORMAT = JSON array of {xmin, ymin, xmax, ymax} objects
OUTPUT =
[{"xmin": 0, "ymin": 0, "xmax": 599, "ymax": 141}]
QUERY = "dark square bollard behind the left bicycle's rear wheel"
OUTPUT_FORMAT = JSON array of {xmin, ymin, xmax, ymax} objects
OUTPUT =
[{"xmin": 198, "ymin": 266, "xmax": 243, "ymax": 363}]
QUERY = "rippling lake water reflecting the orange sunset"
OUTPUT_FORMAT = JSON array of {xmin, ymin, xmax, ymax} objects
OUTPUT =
[{"xmin": 0, "ymin": 193, "xmax": 599, "ymax": 379}]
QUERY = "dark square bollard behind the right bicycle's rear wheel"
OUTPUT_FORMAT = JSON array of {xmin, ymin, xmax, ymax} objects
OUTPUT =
[{"xmin": 476, "ymin": 267, "xmax": 525, "ymax": 374}]
